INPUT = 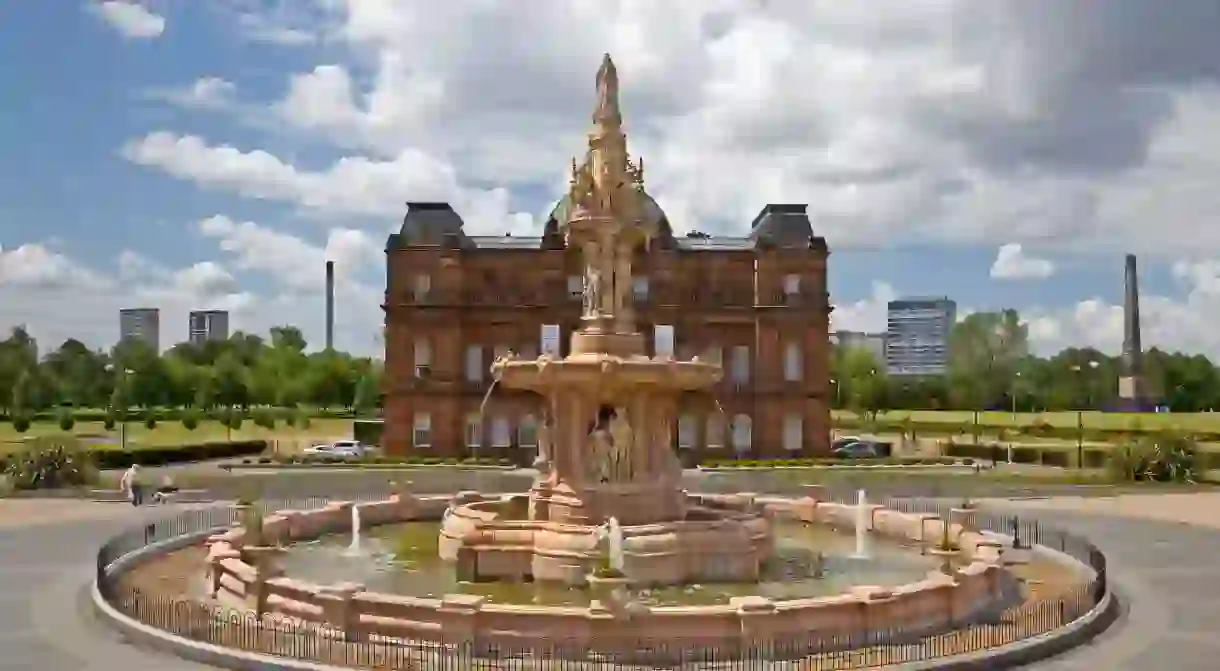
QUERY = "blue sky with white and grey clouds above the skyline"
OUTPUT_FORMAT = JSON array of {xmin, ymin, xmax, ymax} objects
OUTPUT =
[{"xmin": 0, "ymin": 0, "xmax": 1220, "ymax": 353}]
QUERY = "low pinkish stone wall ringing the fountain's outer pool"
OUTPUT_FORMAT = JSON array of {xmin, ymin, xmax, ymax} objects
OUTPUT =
[{"xmin": 207, "ymin": 494, "xmax": 1014, "ymax": 656}]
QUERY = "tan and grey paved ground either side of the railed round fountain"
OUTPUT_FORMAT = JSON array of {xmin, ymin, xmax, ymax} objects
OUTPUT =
[{"xmin": 7, "ymin": 493, "xmax": 1220, "ymax": 671}]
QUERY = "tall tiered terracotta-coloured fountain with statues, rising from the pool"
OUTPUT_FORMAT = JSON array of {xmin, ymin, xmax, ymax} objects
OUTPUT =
[{"xmin": 440, "ymin": 56, "xmax": 772, "ymax": 584}]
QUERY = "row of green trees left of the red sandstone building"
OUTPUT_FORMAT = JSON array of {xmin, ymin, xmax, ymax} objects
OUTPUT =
[{"xmin": 0, "ymin": 326, "xmax": 382, "ymax": 421}]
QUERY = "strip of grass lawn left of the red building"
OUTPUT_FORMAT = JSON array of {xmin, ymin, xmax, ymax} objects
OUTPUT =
[{"xmin": 0, "ymin": 418, "xmax": 351, "ymax": 451}]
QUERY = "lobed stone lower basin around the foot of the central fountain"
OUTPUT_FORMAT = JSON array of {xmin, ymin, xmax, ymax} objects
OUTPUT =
[{"xmin": 438, "ymin": 492, "xmax": 772, "ymax": 586}]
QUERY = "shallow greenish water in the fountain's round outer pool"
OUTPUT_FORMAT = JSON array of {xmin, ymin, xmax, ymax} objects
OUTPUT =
[{"xmin": 281, "ymin": 520, "xmax": 938, "ymax": 606}]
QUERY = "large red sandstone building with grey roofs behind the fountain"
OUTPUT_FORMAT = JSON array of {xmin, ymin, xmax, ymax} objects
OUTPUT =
[{"xmin": 382, "ymin": 198, "xmax": 831, "ymax": 461}]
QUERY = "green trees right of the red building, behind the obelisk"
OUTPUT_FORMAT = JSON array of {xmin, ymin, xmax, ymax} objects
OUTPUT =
[{"xmin": 832, "ymin": 310, "xmax": 1220, "ymax": 414}]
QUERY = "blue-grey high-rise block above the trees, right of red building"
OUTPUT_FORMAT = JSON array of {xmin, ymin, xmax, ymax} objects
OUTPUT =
[{"xmin": 886, "ymin": 296, "xmax": 958, "ymax": 376}]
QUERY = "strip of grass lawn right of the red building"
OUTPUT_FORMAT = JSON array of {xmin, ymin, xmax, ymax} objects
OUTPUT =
[{"xmin": 834, "ymin": 410, "xmax": 1220, "ymax": 432}]
